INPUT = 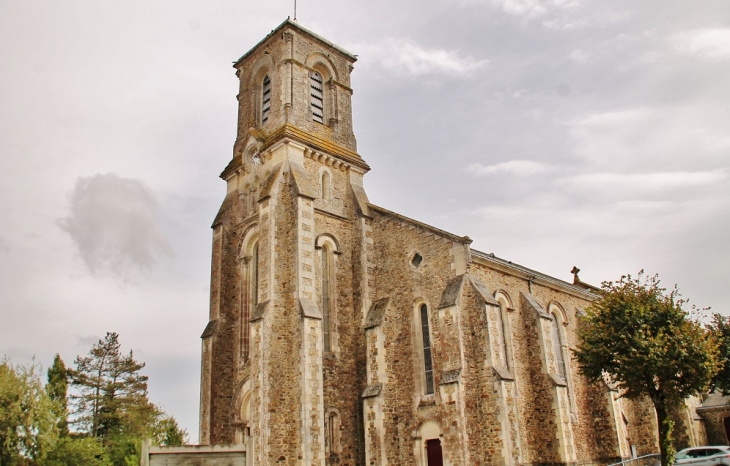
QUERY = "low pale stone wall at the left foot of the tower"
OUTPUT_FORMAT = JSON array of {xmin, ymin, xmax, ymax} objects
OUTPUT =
[{"xmin": 140, "ymin": 441, "xmax": 246, "ymax": 466}]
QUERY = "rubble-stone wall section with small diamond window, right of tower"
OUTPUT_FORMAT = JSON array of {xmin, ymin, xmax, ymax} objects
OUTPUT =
[{"xmin": 369, "ymin": 211, "xmax": 466, "ymax": 465}]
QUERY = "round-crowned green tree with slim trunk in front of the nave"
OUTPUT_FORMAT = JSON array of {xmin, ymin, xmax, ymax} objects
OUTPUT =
[{"xmin": 575, "ymin": 271, "xmax": 717, "ymax": 466}]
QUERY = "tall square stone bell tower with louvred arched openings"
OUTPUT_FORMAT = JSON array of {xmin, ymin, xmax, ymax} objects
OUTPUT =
[{"xmin": 200, "ymin": 20, "xmax": 369, "ymax": 466}]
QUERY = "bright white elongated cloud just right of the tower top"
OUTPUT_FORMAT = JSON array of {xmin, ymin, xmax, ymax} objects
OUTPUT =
[{"xmin": 351, "ymin": 38, "xmax": 489, "ymax": 75}]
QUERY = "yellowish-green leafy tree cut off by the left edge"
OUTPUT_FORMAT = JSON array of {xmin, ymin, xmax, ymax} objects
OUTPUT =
[{"xmin": 0, "ymin": 359, "xmax": 59, "ymax": 466}]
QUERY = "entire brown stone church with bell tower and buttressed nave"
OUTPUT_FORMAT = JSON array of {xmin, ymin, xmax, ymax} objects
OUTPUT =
[{"xmin": 200, "ymin": 20, "xmax": 702, "ymax": 466}]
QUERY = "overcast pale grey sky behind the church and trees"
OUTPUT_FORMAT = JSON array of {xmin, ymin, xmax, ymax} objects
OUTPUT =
[{"xmin": 0, "ymin": 0, "xmax": 730, "ymax": 441}]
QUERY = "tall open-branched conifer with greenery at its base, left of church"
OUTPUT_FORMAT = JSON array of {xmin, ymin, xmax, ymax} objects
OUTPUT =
[{"xmin": 69, "ymin": 332, "xmax": 187, "ymax": 466}]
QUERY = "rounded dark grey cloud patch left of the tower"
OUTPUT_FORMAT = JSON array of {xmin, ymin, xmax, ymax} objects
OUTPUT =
[{"xmin": 57, "ymin": 173, "xmax": 172, "ymax": 277}]
